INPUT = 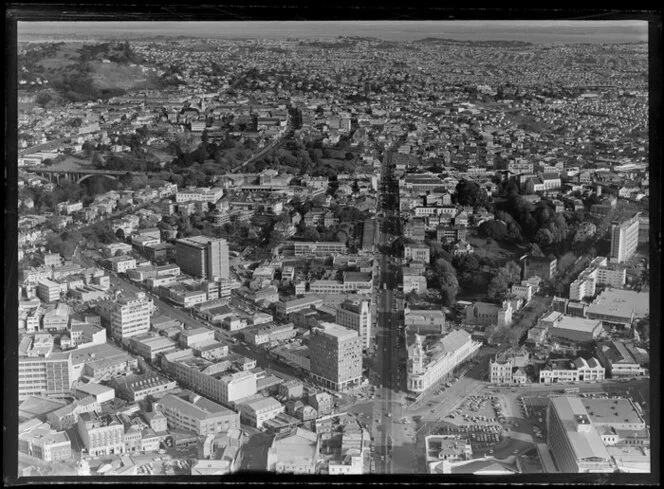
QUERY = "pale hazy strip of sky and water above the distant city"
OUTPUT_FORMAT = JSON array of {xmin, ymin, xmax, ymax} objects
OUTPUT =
[{"xmin": 18, "ymin": 20, "xmax": 648, "ymax": 43}]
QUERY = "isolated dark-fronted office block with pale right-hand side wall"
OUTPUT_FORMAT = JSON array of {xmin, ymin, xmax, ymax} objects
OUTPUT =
[{"xmin": 175, "ymin": 236, "xmax": 229, "ymax": 280}]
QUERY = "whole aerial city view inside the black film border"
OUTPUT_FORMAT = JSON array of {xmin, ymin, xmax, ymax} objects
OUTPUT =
[{"xmin": 10, "ymin": 22, "xmax": 658, "ymax": 480}]
